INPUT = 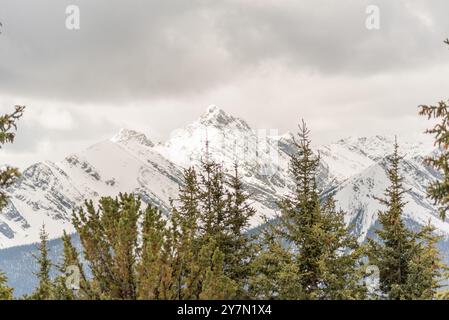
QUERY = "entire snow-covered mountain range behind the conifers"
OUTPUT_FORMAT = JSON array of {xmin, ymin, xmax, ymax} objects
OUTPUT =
[{"xmin": 0, "ymin": 106, "xmax": 449, "ymax": 248}]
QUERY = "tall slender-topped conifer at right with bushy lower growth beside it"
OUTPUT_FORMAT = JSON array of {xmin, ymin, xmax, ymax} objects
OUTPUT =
[{"xmin": 368, "ymin": 142, "xmax": 442, "ymax": 300}]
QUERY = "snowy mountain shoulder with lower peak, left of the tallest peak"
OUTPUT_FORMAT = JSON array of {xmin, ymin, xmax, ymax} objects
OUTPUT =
[{"xmin": 0, "ymin": 130, "xmax": 181, "ymax": 248}]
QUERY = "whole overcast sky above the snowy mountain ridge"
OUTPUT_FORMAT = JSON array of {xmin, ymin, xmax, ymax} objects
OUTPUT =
[{"xmin": 0, "ymin": 0, "xmax": 449, "ymax": 167}]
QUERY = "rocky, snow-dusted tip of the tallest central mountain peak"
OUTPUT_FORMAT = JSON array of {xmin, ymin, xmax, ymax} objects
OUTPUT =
[{"xmin": 199, "ymin": 105, "xmax": 251, "ymax": 130}]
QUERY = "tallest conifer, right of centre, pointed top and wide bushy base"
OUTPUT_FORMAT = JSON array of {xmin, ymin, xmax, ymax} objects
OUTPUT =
[{"xmin": 254, "ymin": 122, "xmax": 363, "ymax": 299}]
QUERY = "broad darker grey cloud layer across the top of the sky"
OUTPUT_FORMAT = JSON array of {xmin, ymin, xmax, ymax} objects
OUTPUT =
[{"xmin": 0, "ymin": 0, "xmax": 449, "ymax": 104}]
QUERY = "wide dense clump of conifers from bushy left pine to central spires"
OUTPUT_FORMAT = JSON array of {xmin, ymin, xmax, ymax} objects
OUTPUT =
[{"xmin": 66, "ymin": 162, "xmax": 254, "ymax": 300}]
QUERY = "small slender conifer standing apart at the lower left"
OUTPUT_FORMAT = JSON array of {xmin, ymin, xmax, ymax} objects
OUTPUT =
[{"xmin": 31, "ymin": 226, "xmax": 53, "ymax": 300}]
